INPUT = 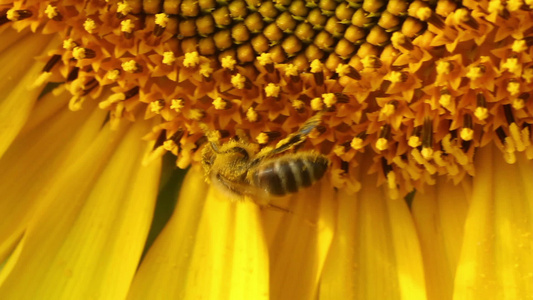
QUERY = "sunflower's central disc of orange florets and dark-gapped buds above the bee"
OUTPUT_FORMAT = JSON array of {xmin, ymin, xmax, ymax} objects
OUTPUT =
[{"xmin": 7, "ymin": 0, "xmax": 533, "ymax": 195}]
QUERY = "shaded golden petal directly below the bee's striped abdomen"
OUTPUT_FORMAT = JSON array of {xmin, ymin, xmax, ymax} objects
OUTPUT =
[{"xmin": 263, "ymin": 180, "xmax": 336, "ymax": 299}]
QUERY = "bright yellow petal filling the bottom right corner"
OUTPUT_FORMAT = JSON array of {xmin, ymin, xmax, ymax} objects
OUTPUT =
[{"xmin": 454, "ymin": 147, "xmax": 533, "ymax": 299}]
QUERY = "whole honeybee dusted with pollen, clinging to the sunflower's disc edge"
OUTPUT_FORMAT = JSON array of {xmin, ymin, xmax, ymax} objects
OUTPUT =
[{"xmin": 202, "ymin": 114, "xmax": 329, "ymax": 202}]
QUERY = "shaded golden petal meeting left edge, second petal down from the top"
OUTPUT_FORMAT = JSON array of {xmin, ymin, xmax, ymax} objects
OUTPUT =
[{"xmin": 0, "ymin": 93, "xmax": 106, "ymax": 261}]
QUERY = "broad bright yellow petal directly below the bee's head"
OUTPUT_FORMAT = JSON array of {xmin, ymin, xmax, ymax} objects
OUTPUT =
[{"xmin": 128, "ymin": 168, "xmax": 268, "ymax": 299}]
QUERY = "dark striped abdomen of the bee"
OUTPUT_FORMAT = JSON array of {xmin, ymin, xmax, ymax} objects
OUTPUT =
[{"xmin": 251, "ymin": 153, "xmax": 329, "ymax": 196}]
